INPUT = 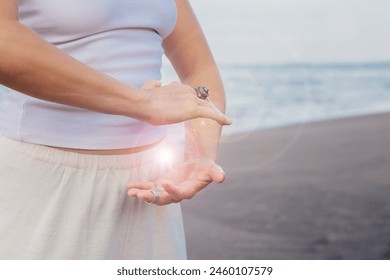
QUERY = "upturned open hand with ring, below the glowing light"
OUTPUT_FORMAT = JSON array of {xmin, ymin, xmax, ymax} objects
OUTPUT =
[{"xmin": 127, "ymin": 158, "xmax": 225, "ymax": 205}]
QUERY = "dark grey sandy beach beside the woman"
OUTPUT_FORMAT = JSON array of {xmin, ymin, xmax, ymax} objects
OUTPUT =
[{"xmin": 183, "ymin": 113, "xmax": 390, "ymax": 259}]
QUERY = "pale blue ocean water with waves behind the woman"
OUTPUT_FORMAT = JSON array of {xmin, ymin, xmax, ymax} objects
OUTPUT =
[{"xmin": 163, "ymin": 62, "xmax": 390, "ymax": 134}]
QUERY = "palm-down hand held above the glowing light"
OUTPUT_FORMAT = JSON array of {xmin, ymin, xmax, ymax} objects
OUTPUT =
[{"xmin": 142, "ymin": 81, "xmax": 232, "ymax": 125}]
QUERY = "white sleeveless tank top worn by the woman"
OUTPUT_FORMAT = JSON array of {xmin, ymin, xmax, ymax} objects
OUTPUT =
[{"xmin": 0, "ymin": 0, "xmax": 176, "ymax": 149}]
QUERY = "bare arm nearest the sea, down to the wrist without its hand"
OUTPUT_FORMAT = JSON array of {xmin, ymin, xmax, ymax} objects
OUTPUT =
[{"xmin": 163, "ymin": 0, "xmax": 225, "ymax": 160}]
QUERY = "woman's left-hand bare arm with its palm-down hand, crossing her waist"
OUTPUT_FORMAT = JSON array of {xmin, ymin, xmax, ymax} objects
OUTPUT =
[{"xmin": 0, "ymin": 0, "xmax": 230, "ymax": 125}]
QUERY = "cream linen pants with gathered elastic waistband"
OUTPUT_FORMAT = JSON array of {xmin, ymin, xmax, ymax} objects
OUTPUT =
[{"xmin": 0, "ymin": 136, "xmax": 186, "ymax": 259}]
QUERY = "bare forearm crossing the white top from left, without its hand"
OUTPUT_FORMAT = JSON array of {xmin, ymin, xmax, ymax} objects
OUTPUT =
[{"xmin": 0, "ymin": 20, "xmax": 143, "ymax": 118}]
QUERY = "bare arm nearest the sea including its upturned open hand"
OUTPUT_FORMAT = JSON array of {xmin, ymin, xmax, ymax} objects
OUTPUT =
[{"xmin": 128, "ymin": 0, "xmax": 232, "ymax": 205}]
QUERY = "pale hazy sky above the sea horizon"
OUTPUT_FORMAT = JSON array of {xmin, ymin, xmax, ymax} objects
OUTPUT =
[{"xmin": 191, "ymin": 0, "xmax": 390, "ymax": 63}]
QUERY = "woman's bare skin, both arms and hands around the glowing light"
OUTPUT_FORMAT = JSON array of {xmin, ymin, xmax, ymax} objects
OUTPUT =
[{"xmin": 0, "ymin": 0, "xmax": 232, "ymax": 205}]
